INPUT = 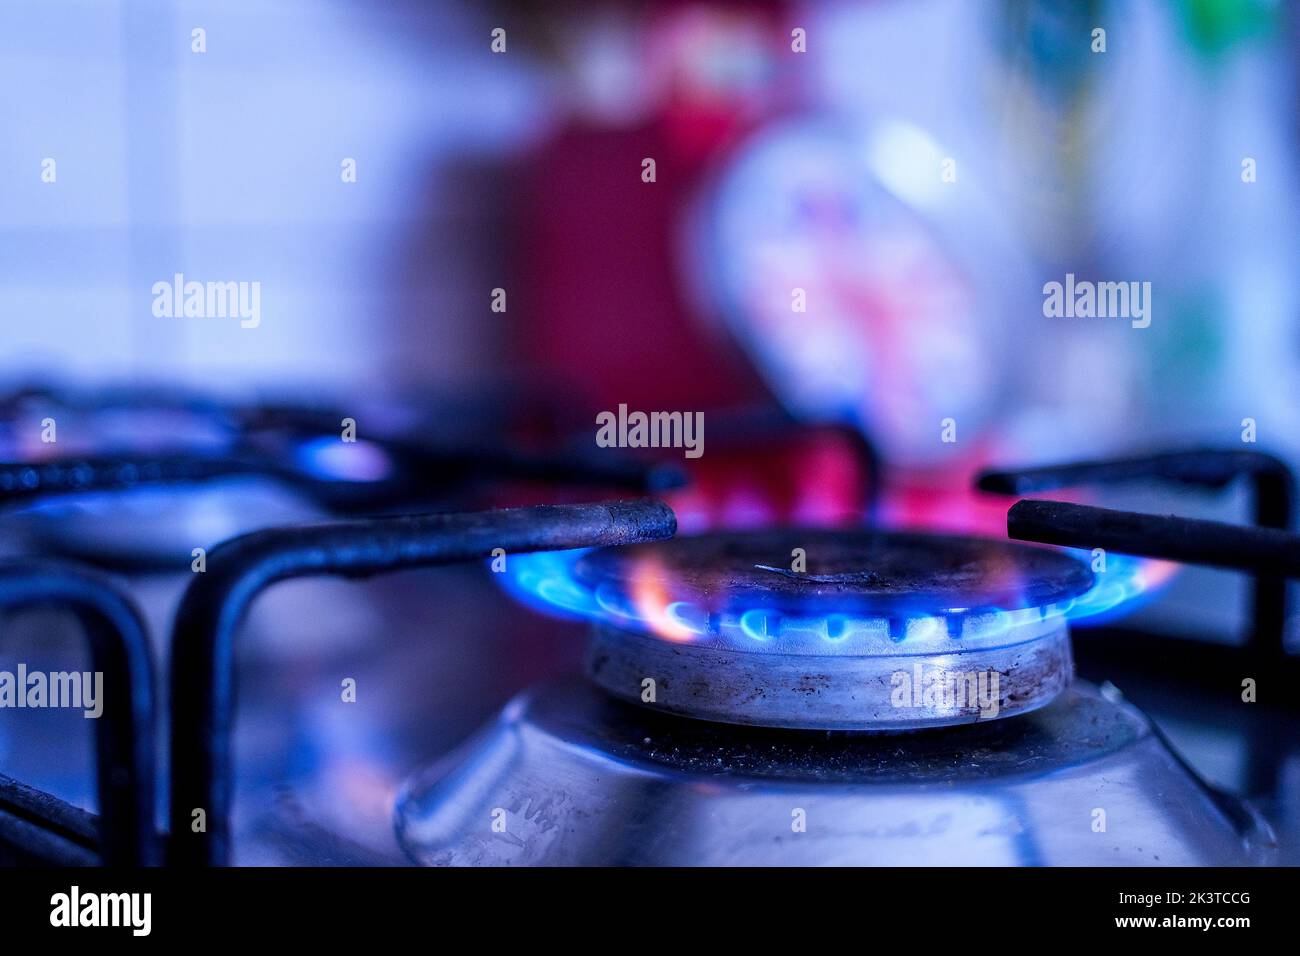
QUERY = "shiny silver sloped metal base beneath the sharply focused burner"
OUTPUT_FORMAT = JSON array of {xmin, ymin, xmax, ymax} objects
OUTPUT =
[{"xmin": 397, "ymin": 680, "xmax": 1274, "ymax": 865}]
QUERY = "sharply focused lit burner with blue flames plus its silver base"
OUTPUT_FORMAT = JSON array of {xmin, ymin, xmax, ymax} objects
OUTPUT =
[{"xmin": 395, "ymin": 515, "xmax": 1271, "ymax": 866}]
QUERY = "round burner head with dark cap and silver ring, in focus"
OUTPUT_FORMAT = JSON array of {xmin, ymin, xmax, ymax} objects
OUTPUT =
[{"xmin": 572, "ymin": 529, "xmax": 1093, "ymax": 730}]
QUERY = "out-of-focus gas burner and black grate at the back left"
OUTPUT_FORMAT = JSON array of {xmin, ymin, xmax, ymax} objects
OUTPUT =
[{"xmin": 0, "ymin": 385, "xmax": 681, "ymax": 570}]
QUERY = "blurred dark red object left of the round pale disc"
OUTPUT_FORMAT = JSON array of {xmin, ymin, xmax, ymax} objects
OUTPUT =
[{"xmin": 510, "ymin": 3, "xmax": 787, "ymax": 411}]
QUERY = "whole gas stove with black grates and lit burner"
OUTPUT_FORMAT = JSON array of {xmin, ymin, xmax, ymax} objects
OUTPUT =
[{"xmin": 0, "ymin": 390, "xmax": 1300, "ymax": 866}]
